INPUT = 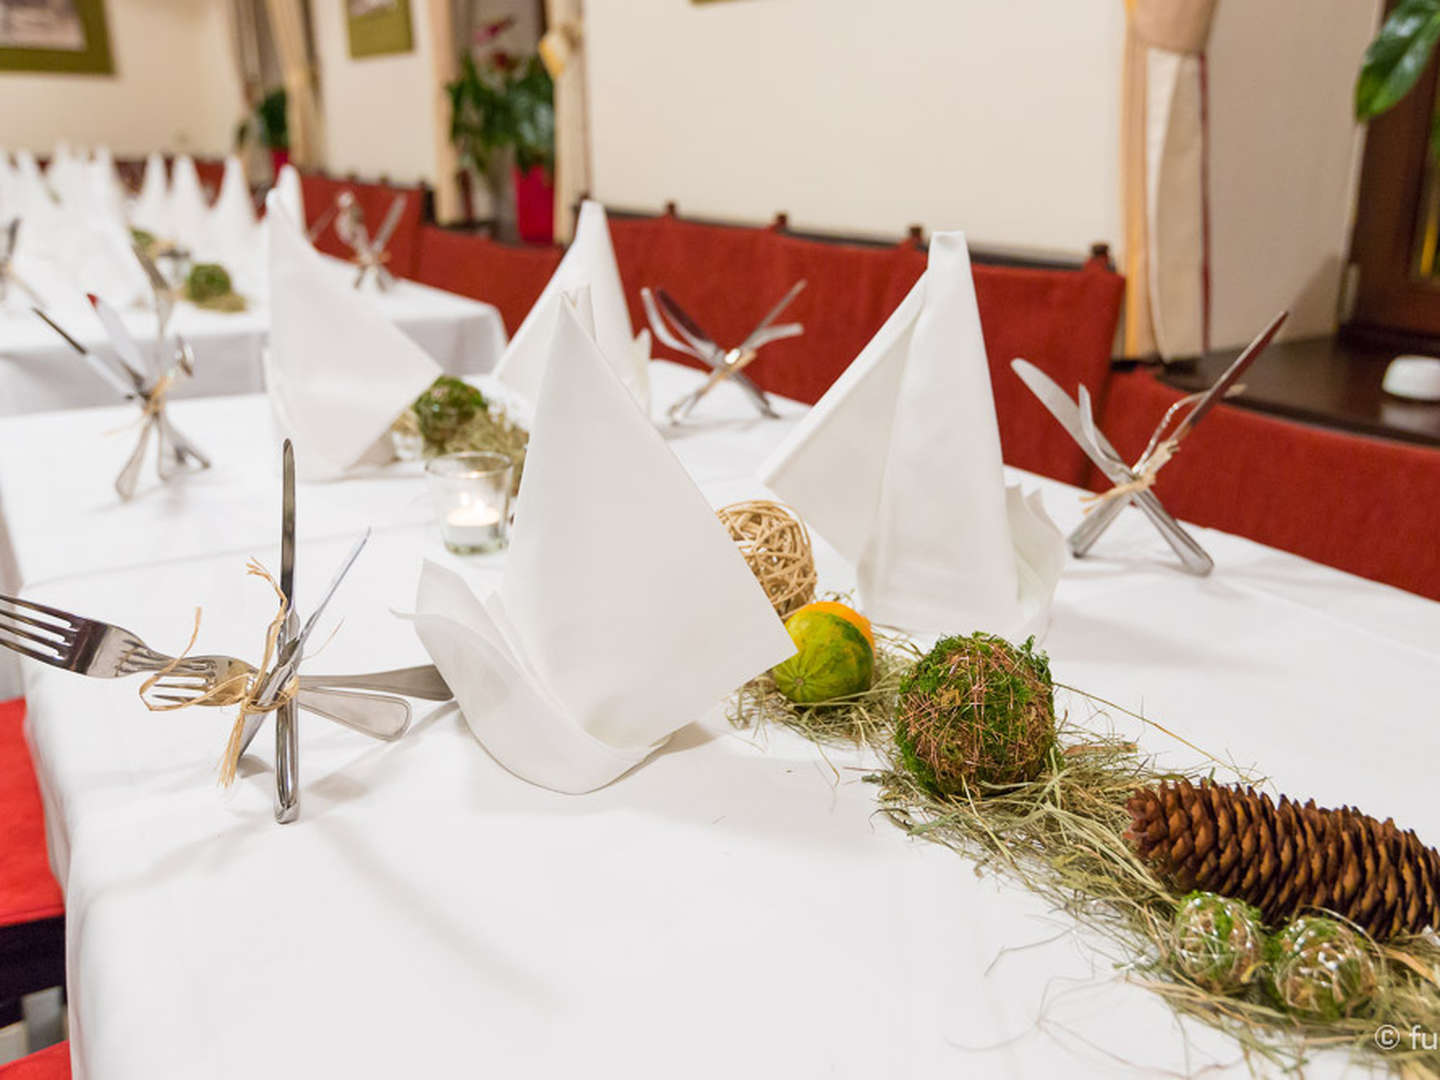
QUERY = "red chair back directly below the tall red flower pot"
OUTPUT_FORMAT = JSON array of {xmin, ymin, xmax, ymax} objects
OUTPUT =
[{"xmin": 412, "ymin": 225, "xmax": 564, "ymax": 334}]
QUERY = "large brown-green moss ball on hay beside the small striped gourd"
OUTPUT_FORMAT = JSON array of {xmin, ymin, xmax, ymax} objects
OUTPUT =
[{"xmin": 894, "ymin": 634, "xmax": 1056, "ymax": 798}]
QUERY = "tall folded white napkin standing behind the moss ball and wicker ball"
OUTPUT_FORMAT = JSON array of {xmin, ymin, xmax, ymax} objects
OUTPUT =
[{"xmin": 762, "ymin": 232, "xmax": 1064, "ymax": 639}]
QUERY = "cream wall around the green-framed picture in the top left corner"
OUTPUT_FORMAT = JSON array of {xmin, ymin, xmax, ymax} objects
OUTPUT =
[{"xmin": 0, "ymin": 0, "xmax": 242, "ymax": 156}]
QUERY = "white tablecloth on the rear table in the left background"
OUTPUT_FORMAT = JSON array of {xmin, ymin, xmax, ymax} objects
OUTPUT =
[{"xmin": 0, "ymin": 259, "xmax": 505, "ymax": 416}]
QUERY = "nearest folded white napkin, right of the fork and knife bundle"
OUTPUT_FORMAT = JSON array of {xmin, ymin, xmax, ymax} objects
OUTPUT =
[{"xmin": 413, "ymin": 304, "xmax": 795, "ymax": 793}]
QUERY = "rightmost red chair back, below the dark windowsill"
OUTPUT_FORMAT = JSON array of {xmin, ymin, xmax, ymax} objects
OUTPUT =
[{"xmin": 1089, "ymin": 370, "xmax": 1440, "ymax": 599}]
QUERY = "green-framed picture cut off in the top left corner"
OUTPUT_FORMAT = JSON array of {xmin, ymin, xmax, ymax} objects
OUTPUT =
[{"xmin": 0, "ymin": 0, "xmax": 115, "ymax": 75}]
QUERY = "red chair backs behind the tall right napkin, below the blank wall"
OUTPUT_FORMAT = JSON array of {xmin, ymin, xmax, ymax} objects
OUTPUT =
[{"xmin": 611, "ymin": 216, "xmax": 1125, "ymax": 484}]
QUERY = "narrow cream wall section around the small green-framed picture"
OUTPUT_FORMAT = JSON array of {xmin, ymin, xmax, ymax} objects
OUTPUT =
[{"xmin": 310, "ymin": 0, "xmax": 444, "ymax": 183}]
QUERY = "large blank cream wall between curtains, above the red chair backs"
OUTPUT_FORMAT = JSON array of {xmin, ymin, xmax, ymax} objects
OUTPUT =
[{"xmin": 586, "ymin": 0, "xmax": 1125, "ymax": 260}]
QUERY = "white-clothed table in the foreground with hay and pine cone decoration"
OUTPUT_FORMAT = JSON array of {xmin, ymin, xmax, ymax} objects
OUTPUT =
[{"xmin": 0, "ymin": 363, "xmax": 1440, "ymax": 1080}]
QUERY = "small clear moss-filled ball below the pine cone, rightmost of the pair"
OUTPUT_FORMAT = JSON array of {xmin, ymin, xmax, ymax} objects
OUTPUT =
[{"xmin": 1270, "ymin": 916, "xmax": 1377, "ymax": 1021}]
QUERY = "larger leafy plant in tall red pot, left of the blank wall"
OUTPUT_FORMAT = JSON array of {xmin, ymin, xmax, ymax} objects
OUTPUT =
[{"xmin": 445, "ymin": 20, "xmax": 554, "ymax": 243}]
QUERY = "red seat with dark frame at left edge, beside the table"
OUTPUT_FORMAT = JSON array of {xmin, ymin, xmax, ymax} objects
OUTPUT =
[{"xmin": 0, "ymin": 700, "xmax": 65, "ymax": 1002}]
